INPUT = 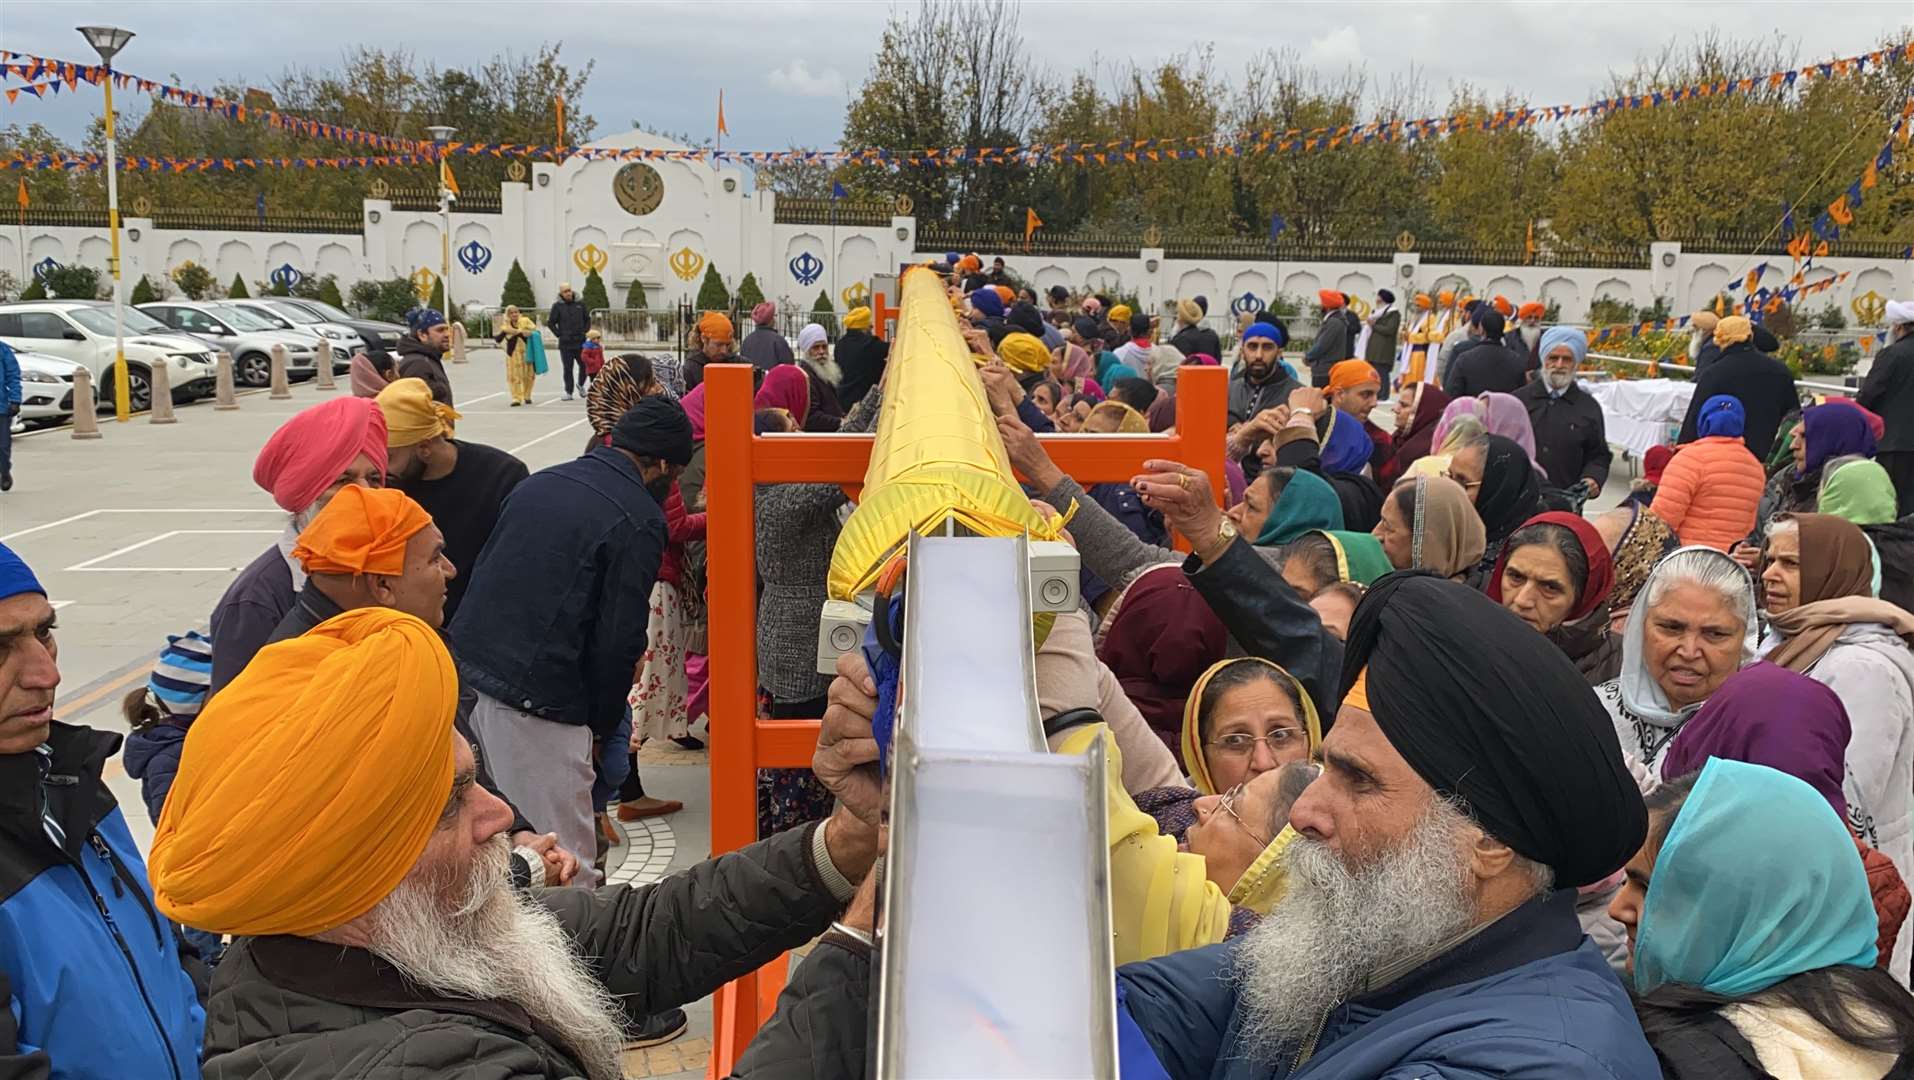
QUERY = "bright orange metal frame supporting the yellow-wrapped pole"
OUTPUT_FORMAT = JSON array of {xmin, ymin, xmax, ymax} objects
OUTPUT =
[{"xmin": 704, "ymin": 333, "xmax": 1229, "ymax": 1076}]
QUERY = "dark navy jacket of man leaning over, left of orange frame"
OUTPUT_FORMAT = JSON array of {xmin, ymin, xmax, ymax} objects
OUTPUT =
[{"xmin": 452, "ymin": 446, "xmax": 668, "ymax": 737}]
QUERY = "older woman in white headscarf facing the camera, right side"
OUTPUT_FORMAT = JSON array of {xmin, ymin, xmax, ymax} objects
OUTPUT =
[{"xmin": 1594, "ymin": 548, "xmax": 1759, "ymax": 795}]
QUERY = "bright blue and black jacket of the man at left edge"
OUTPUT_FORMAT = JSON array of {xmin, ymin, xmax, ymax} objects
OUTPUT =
[{"xmin": 0, "ymin": 722, "xmax": 207, "ymax": 1080}]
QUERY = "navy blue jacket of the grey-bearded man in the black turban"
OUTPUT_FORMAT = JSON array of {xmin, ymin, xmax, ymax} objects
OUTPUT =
[{"xmin": 1118, "ymin": 889, "xmax": 1661, "ymax": 1080}]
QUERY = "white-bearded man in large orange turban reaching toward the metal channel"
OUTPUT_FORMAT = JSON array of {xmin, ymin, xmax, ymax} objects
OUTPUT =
[{"xmin": 151, "ymin": 609, "xmax": 882, "ymax": 1080}]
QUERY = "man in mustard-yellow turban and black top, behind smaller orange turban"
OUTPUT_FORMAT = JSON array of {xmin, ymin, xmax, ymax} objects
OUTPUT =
[{"xmin": 375, "ymin": 379, "xmax": 530, "ymax": 622}]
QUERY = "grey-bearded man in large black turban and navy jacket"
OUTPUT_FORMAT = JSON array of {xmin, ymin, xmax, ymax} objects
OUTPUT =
[{"xmin": 1118, "ymin": 573, "xmax": 1659, "ymax": 1078}]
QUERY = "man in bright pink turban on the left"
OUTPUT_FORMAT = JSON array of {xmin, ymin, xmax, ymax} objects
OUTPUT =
[{"xmin": 209, "ymin": 398, "xmax": 385, "ymax": 693}]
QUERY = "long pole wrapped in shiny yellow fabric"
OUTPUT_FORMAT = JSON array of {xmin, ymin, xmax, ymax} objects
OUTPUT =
[{"xmin": 829, "ymin": 266, "xmax": 1060, "ymax": 599}]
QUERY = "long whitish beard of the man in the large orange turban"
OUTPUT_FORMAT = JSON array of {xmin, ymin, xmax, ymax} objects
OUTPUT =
[{"xmin": 367, "ymin": 837, "xmax": 624, "ymax": 1080}]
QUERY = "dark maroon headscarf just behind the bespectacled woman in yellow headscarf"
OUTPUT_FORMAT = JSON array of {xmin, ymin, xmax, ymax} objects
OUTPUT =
[{"xmin": 1097, "ymin": 565, "xmax": 1229, "ymax": 768}]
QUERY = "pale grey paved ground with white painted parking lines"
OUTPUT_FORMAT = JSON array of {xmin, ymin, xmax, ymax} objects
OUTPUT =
[{"xmin": 0, "ymin": 350, "xmax": 1629, "ymax": 1080}]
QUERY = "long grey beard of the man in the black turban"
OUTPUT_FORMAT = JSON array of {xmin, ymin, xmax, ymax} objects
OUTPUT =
[{"xmin": 1233, "ymin": 800, "xmax": 1476, "ymax": 1057}]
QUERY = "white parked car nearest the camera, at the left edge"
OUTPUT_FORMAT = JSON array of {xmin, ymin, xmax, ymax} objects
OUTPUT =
[{"xmin": 0, "ymin": 301, "xmax": 216, "ymax": 412}]
